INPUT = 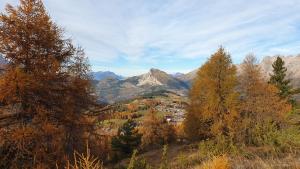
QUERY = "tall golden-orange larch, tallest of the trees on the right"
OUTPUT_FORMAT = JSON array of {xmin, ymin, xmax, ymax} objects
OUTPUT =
[{"xmin": 184, "ymin": 47, "xmax": 238, "ymax": 139}]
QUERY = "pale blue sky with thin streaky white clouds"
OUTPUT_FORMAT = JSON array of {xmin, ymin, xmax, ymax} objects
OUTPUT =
[{"xmin": 0, "ymin": 0, "xmax": 300, "ymax": 76}]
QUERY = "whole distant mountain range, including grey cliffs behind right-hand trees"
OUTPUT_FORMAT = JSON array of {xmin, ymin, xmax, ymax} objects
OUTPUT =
[{"xmin": 95, "ymin": 55, "xmax": 300, "ymax": 103}]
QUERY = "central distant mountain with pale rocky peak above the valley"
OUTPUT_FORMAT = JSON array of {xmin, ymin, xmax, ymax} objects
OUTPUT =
[{"xmin": 96, "ymin": 69, "xmax": 188, "ymax": 103}]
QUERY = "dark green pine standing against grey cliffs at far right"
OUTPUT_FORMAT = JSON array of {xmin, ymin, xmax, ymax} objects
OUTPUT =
[{"xmin": 269, "ymin": 56, "xmax": 294, "ymax": 103}]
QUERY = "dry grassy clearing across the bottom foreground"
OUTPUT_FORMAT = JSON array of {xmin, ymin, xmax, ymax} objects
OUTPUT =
[{"xmin": 108, "ymin": 144, "xmax": 300, "ymax": 169}]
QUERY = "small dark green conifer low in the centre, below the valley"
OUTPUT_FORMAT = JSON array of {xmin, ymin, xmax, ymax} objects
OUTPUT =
[{"xmin": 111, "ymin": 120, "xmax": 141, "ymax": 155}]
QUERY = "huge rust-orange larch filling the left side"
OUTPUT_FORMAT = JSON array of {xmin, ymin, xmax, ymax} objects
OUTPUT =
[{"xmin": 0, "ymin": 0, "xmax": 94, "ymax": 168}]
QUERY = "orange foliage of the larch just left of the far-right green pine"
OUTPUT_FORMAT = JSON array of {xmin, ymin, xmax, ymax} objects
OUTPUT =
[{"xmin": 239, "ymin": 55, "xmax": 291, "ymax": 122}]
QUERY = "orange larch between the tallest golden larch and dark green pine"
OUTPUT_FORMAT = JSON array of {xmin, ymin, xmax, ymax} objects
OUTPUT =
[{"xmin": 237, "ymin": 55, "xmax": 291, "ymax": 144}]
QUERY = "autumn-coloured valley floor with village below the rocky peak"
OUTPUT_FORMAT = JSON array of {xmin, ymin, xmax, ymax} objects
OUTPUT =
[{"xmin": 93, "ymin": 91, "xmax": 188, "ymax": 136}]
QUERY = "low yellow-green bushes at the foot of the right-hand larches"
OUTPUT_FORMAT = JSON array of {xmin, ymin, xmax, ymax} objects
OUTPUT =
[{"xmin": 199, "ymin": 123, "xmax": 300, "ymax": 157}]
